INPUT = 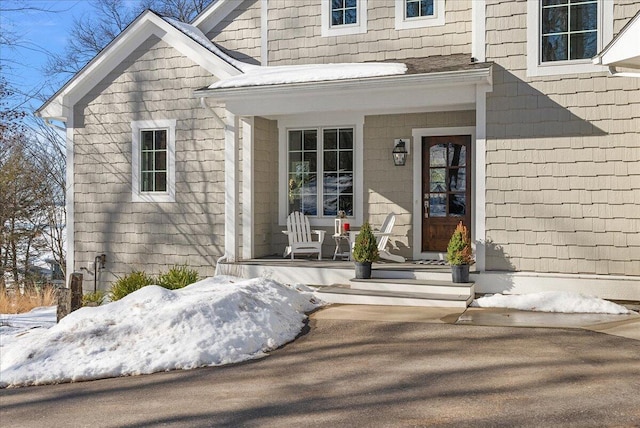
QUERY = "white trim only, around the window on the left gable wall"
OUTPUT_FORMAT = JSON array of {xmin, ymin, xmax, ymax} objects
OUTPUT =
[{"xmin": 131, "ymin": 119, "xmax": 176, "ymax": 202}]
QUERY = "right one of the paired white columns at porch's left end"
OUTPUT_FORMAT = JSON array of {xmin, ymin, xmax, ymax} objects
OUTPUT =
[{"xmin": 241, "ymin": 117, "xmax": 255, "ymax": 260}]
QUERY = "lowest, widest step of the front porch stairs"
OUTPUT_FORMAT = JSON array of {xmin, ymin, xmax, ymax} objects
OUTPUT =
[{"xmin": 315, "ymin": 285, "xmax": 474, "ymax": 308}]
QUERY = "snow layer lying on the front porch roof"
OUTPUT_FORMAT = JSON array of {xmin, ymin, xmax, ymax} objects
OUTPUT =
[{"xmin": 209, "ymin": 62, "xmax": 407, "ymax": 89}]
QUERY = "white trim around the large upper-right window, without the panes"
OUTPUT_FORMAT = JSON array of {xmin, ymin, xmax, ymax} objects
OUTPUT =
[{"xmin": 527, "ymin": 0, "xmax": 615, "ymax": 77}]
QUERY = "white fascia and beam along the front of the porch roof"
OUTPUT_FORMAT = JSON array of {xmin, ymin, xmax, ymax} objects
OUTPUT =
[{"xmin": 195, "ymin": 68, "xmax": 492, "ymax": 117}]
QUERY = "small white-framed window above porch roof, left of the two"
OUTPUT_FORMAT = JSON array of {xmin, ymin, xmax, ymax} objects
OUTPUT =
[{"xmin": 321, "ymin": 0, "xmax": 367, "ymax": 37}]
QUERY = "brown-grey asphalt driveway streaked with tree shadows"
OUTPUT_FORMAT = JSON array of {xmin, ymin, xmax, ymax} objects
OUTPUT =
[{"xmin": 0, "ymin": 306, "xmax": 640, "ymax": 428}]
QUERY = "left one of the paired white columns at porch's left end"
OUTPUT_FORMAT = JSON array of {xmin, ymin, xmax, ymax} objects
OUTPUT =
[{"xmin": 224, "ymin": 110, "xmax": 240, "ymax": 262}]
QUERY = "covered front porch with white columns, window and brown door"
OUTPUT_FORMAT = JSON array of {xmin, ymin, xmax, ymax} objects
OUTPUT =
[{"xmin": 196, "ymin": 55, "xmax": 492, "ymax": 300}]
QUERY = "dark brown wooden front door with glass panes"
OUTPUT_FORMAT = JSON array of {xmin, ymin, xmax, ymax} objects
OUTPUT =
[{"xmin": 422, "ymin": 135, "xmax": 471, "ymax": 252}]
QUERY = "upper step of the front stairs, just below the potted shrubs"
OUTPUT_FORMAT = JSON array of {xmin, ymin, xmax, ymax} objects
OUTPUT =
[{"xmin": 349, "ymin": 278, "xmax": 475, "ymax": 296}]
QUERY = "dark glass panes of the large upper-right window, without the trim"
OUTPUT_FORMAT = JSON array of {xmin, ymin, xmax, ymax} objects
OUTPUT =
[{"xmin": 540, "ymin": 0, "xmax": 598, "ymax": 62}]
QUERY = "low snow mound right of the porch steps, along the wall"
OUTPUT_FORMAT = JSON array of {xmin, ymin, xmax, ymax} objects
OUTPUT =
[{"xmin": 471, "ymin": 291, "xmax": 632, "ymax": 315}]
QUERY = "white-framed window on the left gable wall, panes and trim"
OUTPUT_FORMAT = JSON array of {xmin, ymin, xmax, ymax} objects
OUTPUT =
[{"xmin": 131, "ymin": 119, "xmax": 176, "ymax": 202}]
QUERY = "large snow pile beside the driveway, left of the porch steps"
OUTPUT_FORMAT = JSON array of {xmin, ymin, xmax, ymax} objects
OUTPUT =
[{"xmin": 0, "ymin": 277, "xmax": 319, "ymax": 387}]
